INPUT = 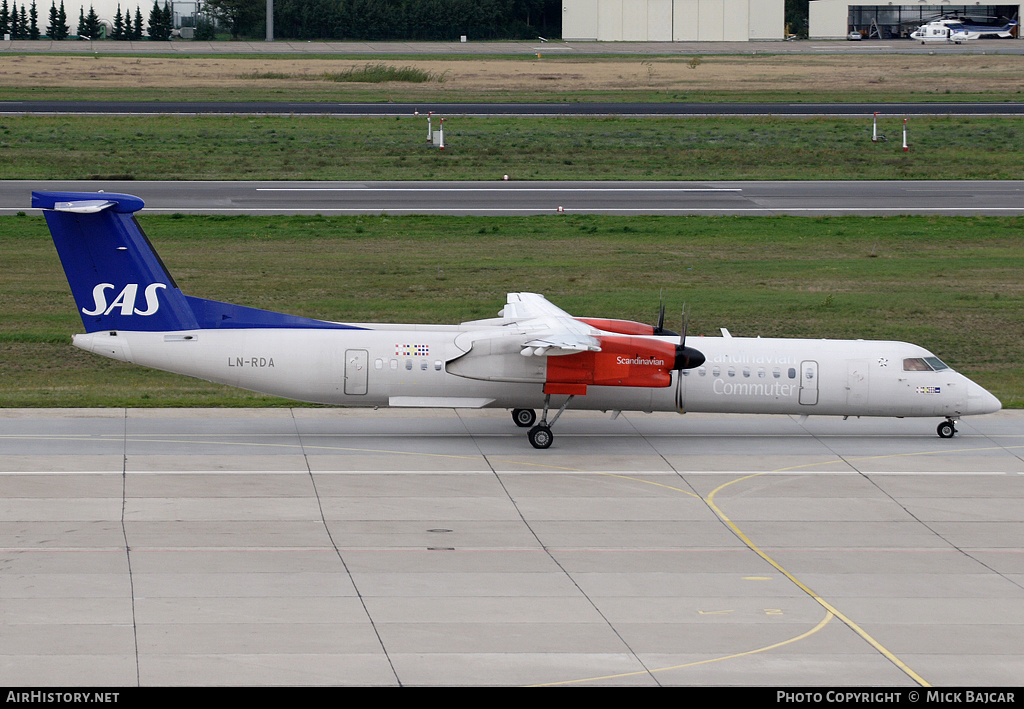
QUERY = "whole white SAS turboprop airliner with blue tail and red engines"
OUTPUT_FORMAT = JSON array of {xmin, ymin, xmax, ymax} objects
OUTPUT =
[{"xmin": 32, "ymin": 192, "xmax": 999, "ymax": 449}]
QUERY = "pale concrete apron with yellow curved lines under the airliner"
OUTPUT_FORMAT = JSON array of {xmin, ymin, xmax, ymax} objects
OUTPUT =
[{"xmin": 0, "ymin": 409, "xmax": 1024, "ymax": 687}]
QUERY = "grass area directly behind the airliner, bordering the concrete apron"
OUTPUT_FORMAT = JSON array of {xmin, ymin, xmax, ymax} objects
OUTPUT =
[{"xmin": 0, "ymin": 215, "xmax": 1024, "ymax": 407}]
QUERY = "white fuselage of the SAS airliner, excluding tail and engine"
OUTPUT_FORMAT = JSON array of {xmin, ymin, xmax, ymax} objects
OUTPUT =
[{"xmin": 75, "ymin": 324, "xmax": 999, "ymax": 417}]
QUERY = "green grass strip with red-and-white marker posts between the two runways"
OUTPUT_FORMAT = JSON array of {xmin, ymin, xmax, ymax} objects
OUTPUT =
[{"xmin": 0, "ymin": 116, "xmax": 1024, "ymax": 180}]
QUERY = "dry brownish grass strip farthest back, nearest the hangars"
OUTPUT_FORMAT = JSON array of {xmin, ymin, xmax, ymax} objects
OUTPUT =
[{"xmin": 0, "ymin": 52, "xmax": 1024, "ymax": 102}]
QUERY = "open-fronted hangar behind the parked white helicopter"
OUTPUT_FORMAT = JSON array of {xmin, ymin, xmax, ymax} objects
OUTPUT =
[{"xmin": 808, "ymin": 0, "xmax": 1021, "ymax": 39}]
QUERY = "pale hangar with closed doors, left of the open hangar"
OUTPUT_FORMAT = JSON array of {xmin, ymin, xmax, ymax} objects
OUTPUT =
[{"xmin": 562, "ymin": 0, "xmax": 782, "ymax": 42}]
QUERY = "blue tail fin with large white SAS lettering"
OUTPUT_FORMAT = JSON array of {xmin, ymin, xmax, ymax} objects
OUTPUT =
[{"xmin": 32, "ymin": 192, "xmax": 199, "ymax": 332}]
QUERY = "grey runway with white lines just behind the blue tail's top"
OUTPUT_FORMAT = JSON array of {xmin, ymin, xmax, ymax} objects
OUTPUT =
[{"xmin": 0, "ymin": 180, "xmax": 1024, "ymax": 216}]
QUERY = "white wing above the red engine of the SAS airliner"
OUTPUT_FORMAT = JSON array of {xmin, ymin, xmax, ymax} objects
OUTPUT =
[{"xmin": 502, "ymin": 293, "xmax": 601, "ymax": 356}]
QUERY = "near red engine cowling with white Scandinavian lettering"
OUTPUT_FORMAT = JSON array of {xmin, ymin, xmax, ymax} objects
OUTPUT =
[{"xmin": 544, "ymin": 336, "xmax": 676, "ymax": 394}]
